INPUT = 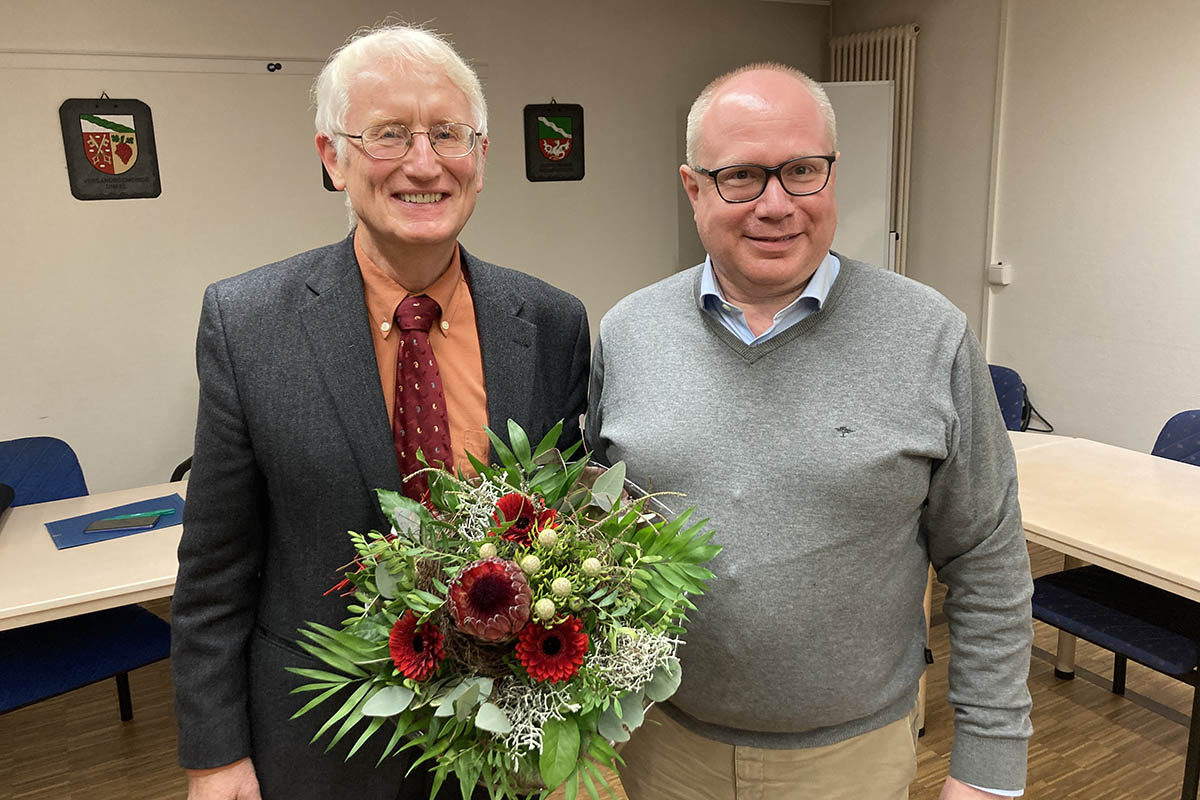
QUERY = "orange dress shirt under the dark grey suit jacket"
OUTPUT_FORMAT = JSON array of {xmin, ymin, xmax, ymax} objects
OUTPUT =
[{"xmin": 354, "ymin": 236, "xmax": 491, "ymax": 475}]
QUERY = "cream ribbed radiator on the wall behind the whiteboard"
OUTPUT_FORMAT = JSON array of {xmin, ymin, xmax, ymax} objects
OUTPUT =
[{"xmin": 829, "ymin": 24, "xmax": 920, "ymax": 275}]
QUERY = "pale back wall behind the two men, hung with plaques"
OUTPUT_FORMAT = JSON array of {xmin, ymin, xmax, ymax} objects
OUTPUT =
[{"xmin": 0, "ymin": 0, "xmax": 829, "ymax": 492}]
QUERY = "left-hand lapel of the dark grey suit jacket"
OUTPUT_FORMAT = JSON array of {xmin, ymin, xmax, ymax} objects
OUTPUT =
[{"xmin": 299, "ymin": 234, "xmax": 401, "ymax": 489}]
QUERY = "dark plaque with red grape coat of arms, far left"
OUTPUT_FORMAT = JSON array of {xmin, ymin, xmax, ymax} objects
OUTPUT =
[{"xmin": 59, "ymin": 97, "xmax": 162, "ymax": 200}]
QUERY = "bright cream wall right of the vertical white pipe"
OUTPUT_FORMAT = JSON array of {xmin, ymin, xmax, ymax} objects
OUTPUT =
[{"xmin": 990, "ymin": 0, "xmax": 1200, "ymax": 451}]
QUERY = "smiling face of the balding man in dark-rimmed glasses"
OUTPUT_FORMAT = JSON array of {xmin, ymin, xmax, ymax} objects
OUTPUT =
[{"xmin": 679, "ymin": 70, "xmax": 838, "ymax": 308}]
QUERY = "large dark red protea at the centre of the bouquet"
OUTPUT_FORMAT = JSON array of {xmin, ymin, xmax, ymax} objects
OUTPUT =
[{"xmin": 449, "ymin": 558, "xmax": 533, "ymax": 642}]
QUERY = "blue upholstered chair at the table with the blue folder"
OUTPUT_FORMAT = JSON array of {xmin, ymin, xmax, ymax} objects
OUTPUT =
[{"xmin": 0, "ymin": 437, "xmax": 170, "ymax": 720}]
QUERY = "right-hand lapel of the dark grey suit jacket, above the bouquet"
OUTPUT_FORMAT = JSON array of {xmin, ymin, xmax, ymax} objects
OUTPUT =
[{"xmin": 462, "ymin": 248, "xmax": 538, "ymax": 450}]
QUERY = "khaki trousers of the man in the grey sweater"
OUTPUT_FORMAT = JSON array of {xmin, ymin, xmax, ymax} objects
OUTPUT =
[{"xmin": 620, "ymin": 706, "xmax": 917, "ymax": 800}]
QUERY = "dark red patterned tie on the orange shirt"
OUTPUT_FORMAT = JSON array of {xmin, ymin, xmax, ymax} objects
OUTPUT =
[{"xmin": 391, "ymin": 295, "xmax": 454, "ymax": 501}]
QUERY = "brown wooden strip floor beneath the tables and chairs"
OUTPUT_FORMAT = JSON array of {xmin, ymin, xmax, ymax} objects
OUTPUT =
[{"xmin": 0, "ymin": 545, "xmax": 1192, "ymax": 800}]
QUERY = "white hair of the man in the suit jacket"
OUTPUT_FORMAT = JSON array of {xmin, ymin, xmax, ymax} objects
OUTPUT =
[{"xmin": 312, "ymin": 22, "xmax": 487, "ymax": 160}]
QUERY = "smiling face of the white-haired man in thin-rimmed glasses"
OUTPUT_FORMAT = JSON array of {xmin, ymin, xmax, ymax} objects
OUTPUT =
[{"xmin": 317, "ymin": 64, "xmax": 487, "ymax": 266}]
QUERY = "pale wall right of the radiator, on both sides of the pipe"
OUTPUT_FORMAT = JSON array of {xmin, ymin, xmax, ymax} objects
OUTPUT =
[{"xmin": 834, "ymin": 0, "xmax": 1200, "ymax": 451}]
